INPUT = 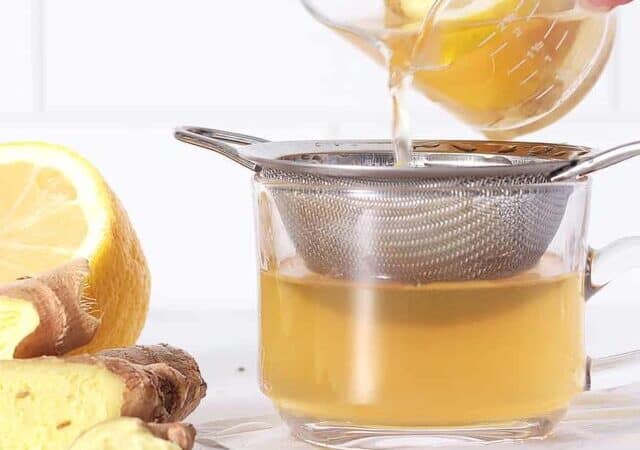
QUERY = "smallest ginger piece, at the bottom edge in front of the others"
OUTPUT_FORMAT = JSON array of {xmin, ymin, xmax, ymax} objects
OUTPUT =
[{"xmin": 69, "ymin": 417, "xmax": 196, "ymax": 450}]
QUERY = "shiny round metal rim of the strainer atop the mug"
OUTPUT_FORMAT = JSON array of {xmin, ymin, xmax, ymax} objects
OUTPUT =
[{"xmin": 238, "ymin": 139, "xmax": 593, "ymax": 179}]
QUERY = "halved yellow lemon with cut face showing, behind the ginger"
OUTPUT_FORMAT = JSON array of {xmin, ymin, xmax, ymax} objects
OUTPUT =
[{"xmin": 0, "ymin": 142, "xmax": 150, "ymax": 351}]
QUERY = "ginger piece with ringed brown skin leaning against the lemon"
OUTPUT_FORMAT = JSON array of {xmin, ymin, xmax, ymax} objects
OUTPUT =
[{"xmin": 0, "ymin": 260, "xmax": 99, "ymax": 359}]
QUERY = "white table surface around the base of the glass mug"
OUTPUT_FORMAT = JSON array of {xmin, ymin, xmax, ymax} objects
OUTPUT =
[{"xmin": 140, "ymin": 303, "xmax": 640, "ymax": 450}]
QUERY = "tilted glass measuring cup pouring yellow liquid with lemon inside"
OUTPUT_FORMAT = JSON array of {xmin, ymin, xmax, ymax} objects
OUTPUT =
[{"xmin": 302, "ymin": 0, "xmax": 615, "ymax": 138}]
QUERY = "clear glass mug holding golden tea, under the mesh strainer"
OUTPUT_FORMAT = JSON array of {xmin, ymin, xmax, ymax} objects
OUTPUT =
[{"xmin": 254, "ymin": 174, "xmax": 640, "ymax": 449}]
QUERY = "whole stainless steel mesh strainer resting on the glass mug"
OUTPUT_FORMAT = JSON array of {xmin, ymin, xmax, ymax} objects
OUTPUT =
[{"xmin": 176, "ymin": 127, "xmax": 640, "ymax": 283}]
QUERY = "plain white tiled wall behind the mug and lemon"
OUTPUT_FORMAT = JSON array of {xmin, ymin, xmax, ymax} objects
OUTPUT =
[{"xmin": 0, "ymin": 0, "xmax": 640, "ymax": 320}]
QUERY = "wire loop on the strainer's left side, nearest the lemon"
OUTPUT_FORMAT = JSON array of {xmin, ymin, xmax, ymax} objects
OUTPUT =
[{"xmin": 174, "ymin": 127, "xmax": 269, "ymax": 172}]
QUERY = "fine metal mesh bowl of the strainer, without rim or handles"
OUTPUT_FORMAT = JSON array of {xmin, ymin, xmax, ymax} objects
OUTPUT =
[{"xmin": 259, "ymin": 160, "xmax": 572, "ymax": 283}]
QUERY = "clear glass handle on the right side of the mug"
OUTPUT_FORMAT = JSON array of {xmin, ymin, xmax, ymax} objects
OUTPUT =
[{"xmin": 585, "ymin": 237, "xmax": 640, "ymax": 390}]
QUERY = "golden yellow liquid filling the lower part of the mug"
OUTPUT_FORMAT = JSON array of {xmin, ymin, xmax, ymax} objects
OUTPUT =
[{"xmin": 261, "ymin": 258, "xmax": 586, "ymax": 427}]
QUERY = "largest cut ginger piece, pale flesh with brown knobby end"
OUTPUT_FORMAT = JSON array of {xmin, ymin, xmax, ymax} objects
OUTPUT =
[{"xmin": 0, "ymin": 345, "xmax": 206, "ymax": 450}]
